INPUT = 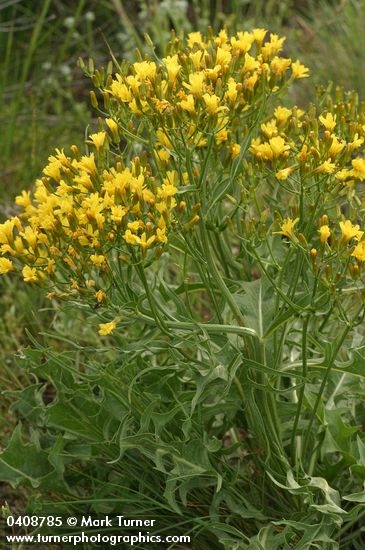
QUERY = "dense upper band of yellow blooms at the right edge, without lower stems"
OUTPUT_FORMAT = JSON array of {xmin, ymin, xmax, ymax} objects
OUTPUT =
[{"xmin": 251, "ymin": 98, "xmax": 365, "ymax": 183}]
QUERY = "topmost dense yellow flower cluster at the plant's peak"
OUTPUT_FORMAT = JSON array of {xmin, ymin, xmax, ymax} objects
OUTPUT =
[{"xmin": 94, "ymin": 29, "xmax": 308, "ymax": 166}]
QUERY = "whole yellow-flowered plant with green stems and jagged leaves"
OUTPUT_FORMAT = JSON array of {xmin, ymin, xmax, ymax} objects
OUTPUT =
[{"xmin": 0, "ymin": 28, "xmax": 365, "ymax": 548}]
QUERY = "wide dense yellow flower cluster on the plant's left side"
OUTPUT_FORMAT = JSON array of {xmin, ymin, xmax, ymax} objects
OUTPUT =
[{"xmin": 0, "ymin": 140, "xmax": 177, "ymax": 301}]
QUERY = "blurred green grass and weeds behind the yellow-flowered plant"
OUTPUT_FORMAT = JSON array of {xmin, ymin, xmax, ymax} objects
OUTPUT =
[{"xmin": 0, "ymin": 0, "xmax": 365, "ymax": 544}]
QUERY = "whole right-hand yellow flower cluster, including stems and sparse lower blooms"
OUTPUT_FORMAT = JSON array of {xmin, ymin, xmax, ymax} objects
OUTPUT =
[{"xmin": 243, "ymin": 84, "xmax": 365, "ymax": 285}]
